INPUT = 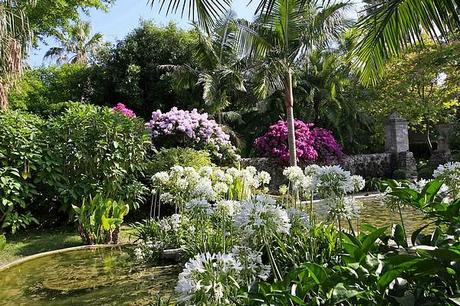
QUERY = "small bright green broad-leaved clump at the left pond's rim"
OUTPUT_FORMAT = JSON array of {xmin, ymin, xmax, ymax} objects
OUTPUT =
[{"xmin": 72, "ymin": 194, "xmax": 129, "ymax": 244}]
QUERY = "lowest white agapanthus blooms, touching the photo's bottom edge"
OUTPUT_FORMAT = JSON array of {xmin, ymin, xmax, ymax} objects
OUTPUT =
[{"xmin": 175, "ymin": 247, "xmax": 270, "ymax": 305}]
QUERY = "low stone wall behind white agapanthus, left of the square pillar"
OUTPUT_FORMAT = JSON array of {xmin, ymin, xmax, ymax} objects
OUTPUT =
[{"xmin": 241, "ymin": 153, "xmax": 397, "ymax": 190}]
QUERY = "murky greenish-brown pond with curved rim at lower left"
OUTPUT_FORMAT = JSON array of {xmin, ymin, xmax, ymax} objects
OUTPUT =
[{"xmin": 0, "ymin": 248, "xmax": 181, "ymax": 305}]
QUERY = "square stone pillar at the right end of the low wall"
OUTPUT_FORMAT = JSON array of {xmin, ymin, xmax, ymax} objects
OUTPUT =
[{"xmin": 385, "ymin": 113, "xmax": 417, "ymax": 178}]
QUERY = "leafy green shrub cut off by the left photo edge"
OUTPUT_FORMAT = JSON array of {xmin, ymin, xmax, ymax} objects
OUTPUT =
[{"xmin": 0, "ymin": 111, "xmax": 44, "ymax": 232}]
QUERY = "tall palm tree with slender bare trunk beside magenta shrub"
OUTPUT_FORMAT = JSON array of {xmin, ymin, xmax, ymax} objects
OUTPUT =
[{"xmin": 241, "ymin": 0, "xmax": 348, "ymax": 166}]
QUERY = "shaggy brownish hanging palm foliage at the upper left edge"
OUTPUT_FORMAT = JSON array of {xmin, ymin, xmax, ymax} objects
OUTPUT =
[{"xmin": 0, "ymin": 0, "xmax": 35, "ymax": 110}]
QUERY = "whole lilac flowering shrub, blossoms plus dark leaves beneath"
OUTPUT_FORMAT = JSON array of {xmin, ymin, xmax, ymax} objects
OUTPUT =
[{"xmin": 147, "ymin": 107, "xmax": 237, "ymax": 165}]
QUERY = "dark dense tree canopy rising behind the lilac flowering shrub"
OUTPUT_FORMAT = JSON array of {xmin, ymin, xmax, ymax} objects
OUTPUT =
[{"xmin": 102, "ymin": 22, "xmax": 201, "ymax": 118}]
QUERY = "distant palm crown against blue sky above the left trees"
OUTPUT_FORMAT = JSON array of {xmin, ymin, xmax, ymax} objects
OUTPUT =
[{"xmin": 44, "ymin": 20, "xmax": 103, "ymax": 65}]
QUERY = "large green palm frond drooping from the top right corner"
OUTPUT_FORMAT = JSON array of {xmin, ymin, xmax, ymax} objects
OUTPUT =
[{"xmin": 353, "ymin": 0, "xmax": 460, "ymax": 84}]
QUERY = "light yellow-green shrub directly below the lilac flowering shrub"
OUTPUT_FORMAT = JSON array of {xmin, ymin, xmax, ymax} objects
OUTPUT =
[{"xmin": 149, "ymin": 148, "xmax": 212, "ymax": 174}]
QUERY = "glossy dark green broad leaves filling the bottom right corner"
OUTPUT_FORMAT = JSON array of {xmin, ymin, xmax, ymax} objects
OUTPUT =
[{"xmin": 251, "ymin": 180, "xmax": 460, "ymax": 305}]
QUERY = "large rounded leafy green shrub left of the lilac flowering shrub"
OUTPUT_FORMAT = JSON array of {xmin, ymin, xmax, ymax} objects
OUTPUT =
[{"xmin": 41, "ymin": 104, "xmax": 150, "ymax": 212}]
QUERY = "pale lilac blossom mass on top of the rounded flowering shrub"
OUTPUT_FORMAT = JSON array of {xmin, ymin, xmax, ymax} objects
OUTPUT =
[{"xmin": 147, "ymin": 107, "xmax": 230, "ymax": 147}]
